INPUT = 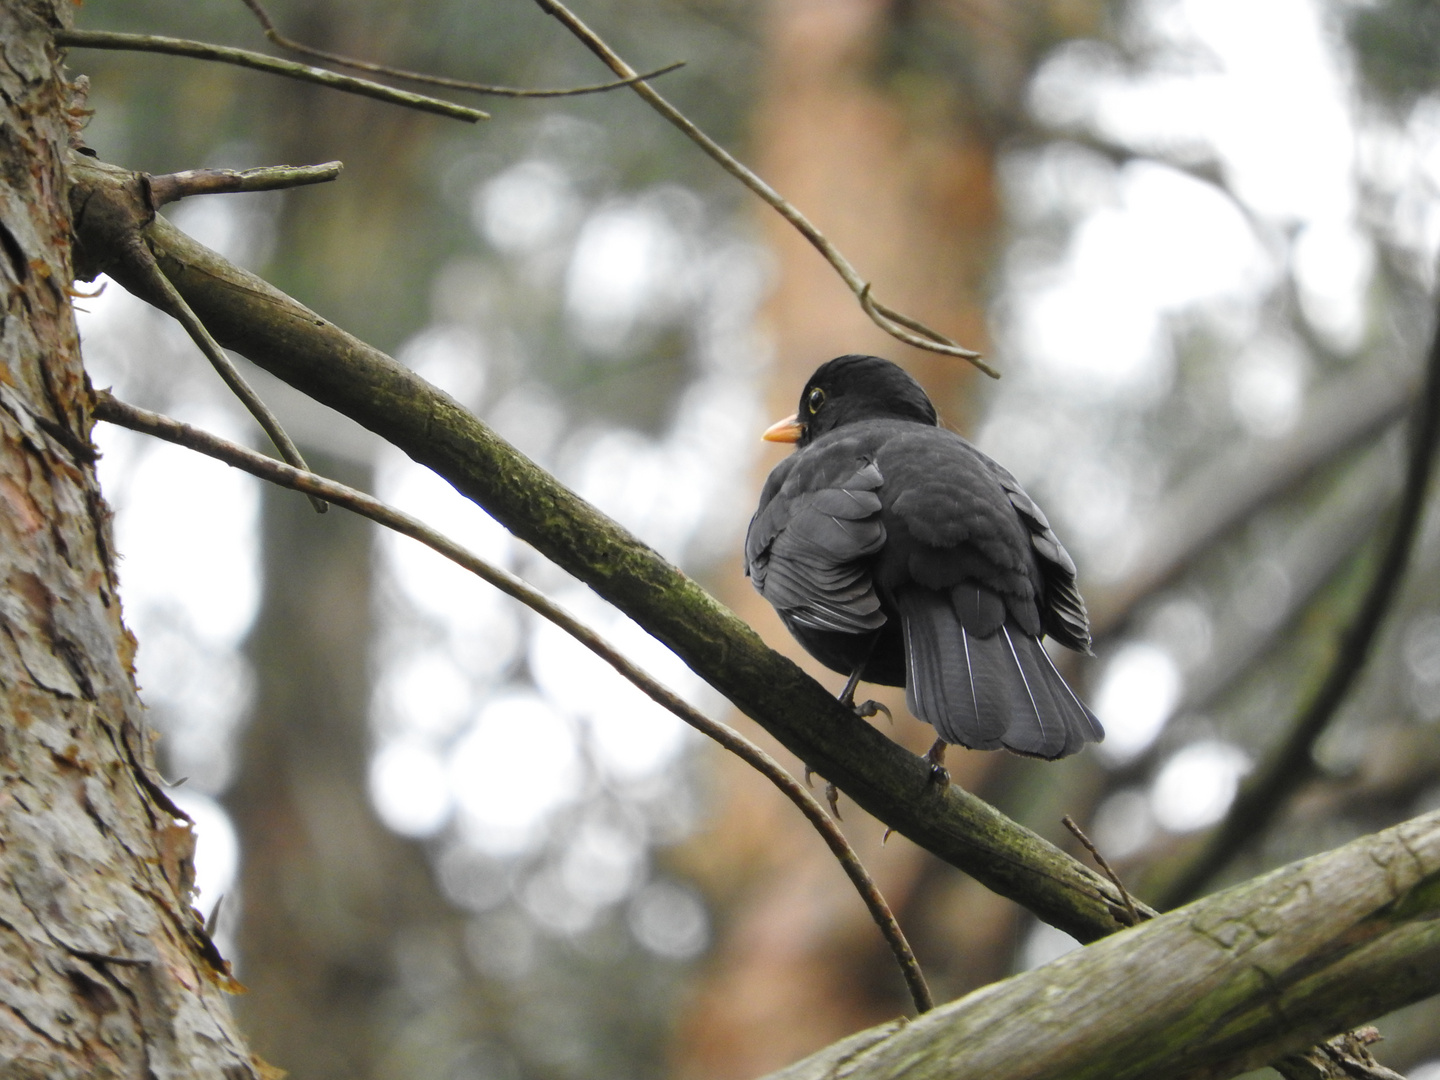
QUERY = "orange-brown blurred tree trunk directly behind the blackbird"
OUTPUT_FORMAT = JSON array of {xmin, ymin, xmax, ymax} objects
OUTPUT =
[{"xmin": 677, "ymin": 0, "xmax": 1031, "ymax": 1080}]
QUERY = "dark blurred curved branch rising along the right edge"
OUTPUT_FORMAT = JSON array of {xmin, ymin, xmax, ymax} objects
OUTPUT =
[{"xmin": 1161, "ymin": 292, "xmax": 1440, "ymax": 909}]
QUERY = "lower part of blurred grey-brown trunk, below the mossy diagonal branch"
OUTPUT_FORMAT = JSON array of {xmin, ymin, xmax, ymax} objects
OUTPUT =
[{"xmin": 226, "ymin": 451, "xmax": 512, "ymax": 1080}]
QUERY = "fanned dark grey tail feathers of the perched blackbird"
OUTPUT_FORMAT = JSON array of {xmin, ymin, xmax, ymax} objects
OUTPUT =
[{"xmin": 894, "ymin": 586, "xmax": 1104, "ymax": 757}]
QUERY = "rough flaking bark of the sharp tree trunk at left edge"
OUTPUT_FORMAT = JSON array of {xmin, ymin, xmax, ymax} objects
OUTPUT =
[{"xmin": 0, "ymin": 0, "xmax": 259, "ymax": 1080}]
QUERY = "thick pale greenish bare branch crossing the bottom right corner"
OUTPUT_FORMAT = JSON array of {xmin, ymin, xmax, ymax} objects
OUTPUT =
[{"xmin": 768, "ymin": 812, "xmax": 1440, "ymax": 1080}]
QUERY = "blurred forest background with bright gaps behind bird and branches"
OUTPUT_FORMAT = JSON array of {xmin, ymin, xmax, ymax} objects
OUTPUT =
[{"xmin": 71, "ymin": 0, "xmax": 1440, "ymax": 1080}]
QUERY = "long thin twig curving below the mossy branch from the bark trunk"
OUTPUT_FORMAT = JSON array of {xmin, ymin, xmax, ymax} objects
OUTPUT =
[{"xmin": 94, "ymin": 390, "xmax": 935, "ymax": 1012}]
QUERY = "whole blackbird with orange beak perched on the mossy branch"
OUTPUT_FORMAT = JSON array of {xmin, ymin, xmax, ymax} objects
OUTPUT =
[{"xmin": 744, "ymin": 354, "xmax": 1104, "ymax": 779}]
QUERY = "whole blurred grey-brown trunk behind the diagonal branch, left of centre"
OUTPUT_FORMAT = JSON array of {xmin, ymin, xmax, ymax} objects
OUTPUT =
[{"xmin": 218, "ymin": 0, "xmax": 503, "ymax": 1080}]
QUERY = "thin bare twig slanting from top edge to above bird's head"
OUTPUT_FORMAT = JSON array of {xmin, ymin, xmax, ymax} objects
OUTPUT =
[{"xmin": 536, "ymin": 0, "xmax": 999, "ymax": 379}]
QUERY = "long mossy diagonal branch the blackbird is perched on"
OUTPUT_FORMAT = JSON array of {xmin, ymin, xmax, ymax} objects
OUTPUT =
[{"xmin": 71, "ymin": 156, "xmax": 1126, "ymax": 942}]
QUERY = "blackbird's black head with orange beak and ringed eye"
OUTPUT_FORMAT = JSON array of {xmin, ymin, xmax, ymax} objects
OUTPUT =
[{"xmin": 762, "ymin": 353, "xmax": 937, "ymax": 446}]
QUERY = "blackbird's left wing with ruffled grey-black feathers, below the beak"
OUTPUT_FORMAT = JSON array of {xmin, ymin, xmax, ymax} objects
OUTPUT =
[{"xmin": 744, "ymin": 452, "xmax": 886, "ymax": 634}]
